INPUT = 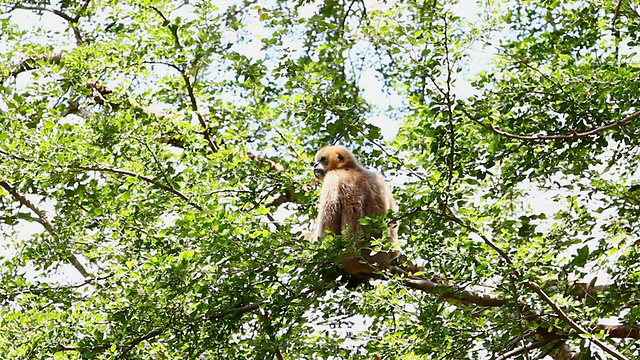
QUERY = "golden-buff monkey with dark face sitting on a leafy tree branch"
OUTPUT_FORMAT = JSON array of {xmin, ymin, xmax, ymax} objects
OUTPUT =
[{"xmin": 313, "ymin": 146, "xmax": 400, "ymax": 288}]
